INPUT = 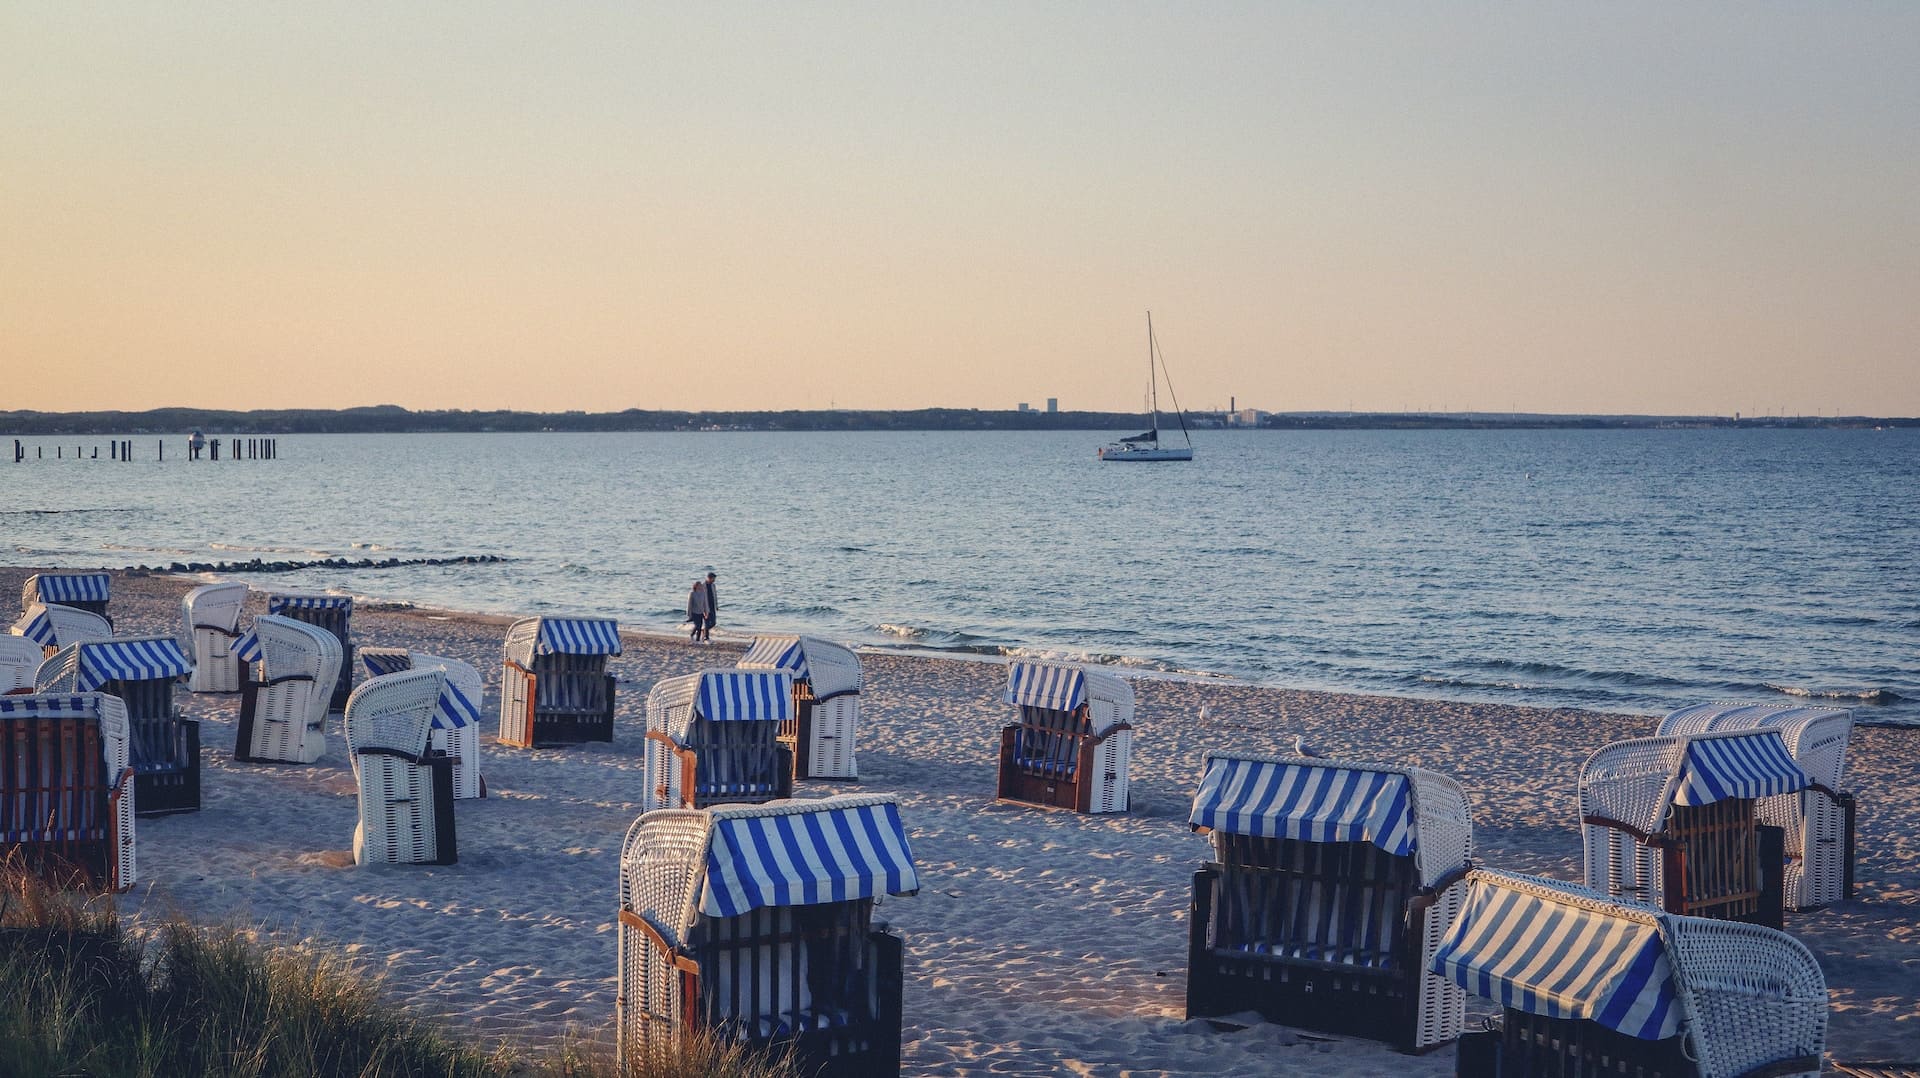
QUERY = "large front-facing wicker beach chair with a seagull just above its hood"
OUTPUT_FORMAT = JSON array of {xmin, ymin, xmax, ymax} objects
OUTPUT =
[{"xmin": 1187, "ymin": 753, "xmax": 1473, "ymax": 1051}]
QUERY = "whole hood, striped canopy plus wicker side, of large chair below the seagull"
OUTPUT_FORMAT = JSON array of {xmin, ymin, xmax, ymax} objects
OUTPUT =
[{"xmin": 1187, "ymin": 753, "xmax": 1473, "ymax": 886}]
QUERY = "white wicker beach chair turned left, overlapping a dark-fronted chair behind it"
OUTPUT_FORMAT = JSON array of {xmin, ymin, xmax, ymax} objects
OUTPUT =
[{"xmin": 234, "ymin": 613, "xmax": 342, "ymax": 763}]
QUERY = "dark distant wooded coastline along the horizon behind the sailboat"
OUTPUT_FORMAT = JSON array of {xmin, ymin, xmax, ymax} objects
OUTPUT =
[{"xmin": 0, "ymin": 405, "xmax": 1920, "ymax": 438}]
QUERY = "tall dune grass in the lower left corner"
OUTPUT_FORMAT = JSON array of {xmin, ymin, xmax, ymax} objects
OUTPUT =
[{"xmin": 0, "ymin": 867, "xmax": 799, "ymax": 1078}]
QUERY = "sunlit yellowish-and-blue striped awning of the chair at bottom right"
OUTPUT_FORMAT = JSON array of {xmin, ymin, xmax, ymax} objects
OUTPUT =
[{"xmin": 1430, "ymin": 878, "xmax": 1680, "ymax": 1040}]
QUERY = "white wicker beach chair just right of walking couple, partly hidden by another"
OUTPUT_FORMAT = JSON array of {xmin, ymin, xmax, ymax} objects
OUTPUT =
[{"xmin": 739, "ymin": 636, "xmax": 860, "ymax": 778}]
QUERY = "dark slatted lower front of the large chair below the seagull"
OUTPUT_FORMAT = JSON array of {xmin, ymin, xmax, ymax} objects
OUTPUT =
[{"xmin": 1187, "ymin": 834, "xmax": 1467, "ymax": 1053}]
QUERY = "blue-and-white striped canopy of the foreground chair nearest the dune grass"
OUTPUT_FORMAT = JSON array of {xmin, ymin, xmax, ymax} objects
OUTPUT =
[{"xmin": 699, "ymin": 797, "xmax": 920, "ymax": 917}]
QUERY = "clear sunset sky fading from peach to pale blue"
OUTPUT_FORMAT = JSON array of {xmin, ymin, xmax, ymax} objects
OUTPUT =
[{"xmin": 0, "ymin": 2, "xmax": 1920, "ymax": 415}]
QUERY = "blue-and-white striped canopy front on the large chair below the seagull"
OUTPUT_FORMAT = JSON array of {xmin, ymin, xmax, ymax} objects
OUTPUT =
[{"xmin": 1187, "ymin": 755, "xmax": 1419, "ymax": 857}]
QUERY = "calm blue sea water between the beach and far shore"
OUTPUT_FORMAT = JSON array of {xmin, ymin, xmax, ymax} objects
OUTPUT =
[{"xmin": 0, "ymin": 430, "xmax": 1920, "ymax": 723}]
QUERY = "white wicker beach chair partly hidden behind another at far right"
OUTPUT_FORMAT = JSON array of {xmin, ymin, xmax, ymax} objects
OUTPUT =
[{"xmin": 1657, "ymin": 703, "xmax": 1855, "ymax": 911}]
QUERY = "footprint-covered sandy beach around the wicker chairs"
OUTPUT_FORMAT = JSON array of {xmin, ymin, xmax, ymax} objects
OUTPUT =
[{"xmin": 0, "ymin": 569, "xmax": 1920, "ymax": 1076}]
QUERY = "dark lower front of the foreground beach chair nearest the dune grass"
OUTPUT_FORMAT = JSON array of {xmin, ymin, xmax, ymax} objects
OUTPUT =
[{"xmin": 620, "ymin": 899, "xmax": 904, "ymax": 1078}]
